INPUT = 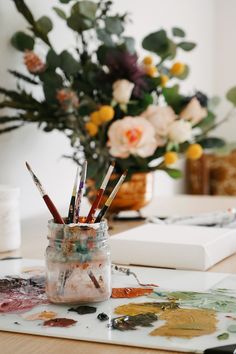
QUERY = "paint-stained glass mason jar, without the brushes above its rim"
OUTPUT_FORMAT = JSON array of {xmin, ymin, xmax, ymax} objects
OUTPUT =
[{"xmin": 46, "ymin": 220, "xmax": 111, "ymax": 303}]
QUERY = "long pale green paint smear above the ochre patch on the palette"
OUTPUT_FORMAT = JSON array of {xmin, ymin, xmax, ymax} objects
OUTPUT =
[{"xmin": 149, "ymin": 289, "xmax": 236, "ymax": 313}]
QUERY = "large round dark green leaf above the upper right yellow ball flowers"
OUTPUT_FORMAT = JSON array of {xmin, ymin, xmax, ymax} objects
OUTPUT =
[{"xmin": 142, "ymin": 30, "xmax": 169, "ymax": 56}]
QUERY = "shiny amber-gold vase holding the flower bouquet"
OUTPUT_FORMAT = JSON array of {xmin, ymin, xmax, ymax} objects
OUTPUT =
[{"xmin": 87, "ymin": 173, "xmax": 153, "ymax": 214}]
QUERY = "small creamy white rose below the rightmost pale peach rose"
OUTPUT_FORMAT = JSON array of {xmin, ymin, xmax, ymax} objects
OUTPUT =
[{"xmin": 168, "ymin": 120, "xmax": 192, "ymax": 144}]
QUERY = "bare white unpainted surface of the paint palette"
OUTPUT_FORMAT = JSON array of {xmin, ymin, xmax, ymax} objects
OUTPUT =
[{"xmin": 0, "ymin": 259, "xmax": 236, "ymax": 353}]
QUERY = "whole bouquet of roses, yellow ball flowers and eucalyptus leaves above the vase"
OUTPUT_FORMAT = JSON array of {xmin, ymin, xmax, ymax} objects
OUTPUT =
[{"xmin": 0, "ymin": 0, "xmax": 236, "ymax": 205}]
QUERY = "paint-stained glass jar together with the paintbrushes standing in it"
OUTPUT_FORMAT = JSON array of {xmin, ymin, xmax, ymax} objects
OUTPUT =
[{"xmin": 26, "ymin": 161, "xmax": 126, "ymax": 303}]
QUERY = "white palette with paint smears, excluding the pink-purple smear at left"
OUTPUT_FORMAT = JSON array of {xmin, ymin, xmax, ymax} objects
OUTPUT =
[{"xmin": 0, "ymin": 259, "xmax": 236, "ymax": 353}]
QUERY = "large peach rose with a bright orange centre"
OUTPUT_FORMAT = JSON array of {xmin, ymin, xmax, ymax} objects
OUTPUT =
[{"xmin": 108, "ymin": 117, "xmax": 157, "ymax": 158}]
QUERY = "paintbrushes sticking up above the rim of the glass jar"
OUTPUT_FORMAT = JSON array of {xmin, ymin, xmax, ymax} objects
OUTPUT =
[{"xmin": 26, "ymin": 161, "xmax": 127, "ymax": 224}]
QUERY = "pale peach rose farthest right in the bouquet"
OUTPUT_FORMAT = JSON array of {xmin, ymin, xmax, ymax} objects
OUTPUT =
[{"xmin": 179, "ymin": 97, "xmax": 207, "ymax": 125}]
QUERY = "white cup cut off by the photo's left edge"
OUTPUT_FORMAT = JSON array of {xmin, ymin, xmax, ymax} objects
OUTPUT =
[{"xmin": 0, "ymin": 185, "xmax": 21, "ymax": 252}]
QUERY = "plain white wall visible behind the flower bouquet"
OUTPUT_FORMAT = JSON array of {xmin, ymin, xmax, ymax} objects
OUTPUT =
[{"xmin": 0, "ymin": 0, "xmax": 236, "ymax": 219}]
